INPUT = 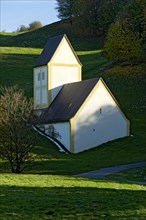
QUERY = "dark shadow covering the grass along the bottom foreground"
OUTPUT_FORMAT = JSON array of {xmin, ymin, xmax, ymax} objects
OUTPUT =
[{"xmin": 0, "ymin": 185, "xmax": 146, "ymax": 220}]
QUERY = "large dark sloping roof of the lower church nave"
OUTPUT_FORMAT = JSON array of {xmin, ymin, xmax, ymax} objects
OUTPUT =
[{"xmin": 35, "ymin": 78, "xmax": 99, "ymax": 124}]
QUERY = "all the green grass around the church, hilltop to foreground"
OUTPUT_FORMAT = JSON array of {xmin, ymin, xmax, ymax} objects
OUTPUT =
[{"xmin": 0, "ymin": 20, "xmax": 146, "ymax": 220}]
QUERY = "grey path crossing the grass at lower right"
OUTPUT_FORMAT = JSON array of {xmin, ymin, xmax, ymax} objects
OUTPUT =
[{"xmin": 75, "ymin": 162, "xmax": 146, "ymax": 184}]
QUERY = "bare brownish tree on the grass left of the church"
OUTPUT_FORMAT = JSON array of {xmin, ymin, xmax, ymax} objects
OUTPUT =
[{"xmin": 0, "ymin": 86, "xmax": 36, "ymax": 173}]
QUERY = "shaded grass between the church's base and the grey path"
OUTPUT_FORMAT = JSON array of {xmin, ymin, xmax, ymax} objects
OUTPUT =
[{"xmin": 0, "ymin": 134, "xmax": 145, "ymax": 175}]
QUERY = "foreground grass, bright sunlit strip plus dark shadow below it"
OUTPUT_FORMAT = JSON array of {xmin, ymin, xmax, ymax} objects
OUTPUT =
[{"xmin": 0, "ymin": 174, "xmax": 146, "ymax": 220}]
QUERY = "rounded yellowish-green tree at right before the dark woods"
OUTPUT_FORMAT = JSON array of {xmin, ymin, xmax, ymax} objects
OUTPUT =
[{"xmin": 104, "ymin": 21, "xmax": 142, "ymax": 64}]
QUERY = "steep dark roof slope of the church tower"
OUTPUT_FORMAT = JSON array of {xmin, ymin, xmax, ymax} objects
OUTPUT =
[{"xmin": 34, "ymin": 34, "xmax": 64, "ymax": 67}]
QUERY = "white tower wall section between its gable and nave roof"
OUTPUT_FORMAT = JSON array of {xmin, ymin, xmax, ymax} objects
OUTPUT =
[{"xmin": 52, "ymin": 66, "xmax": 80, "ymax": 101}]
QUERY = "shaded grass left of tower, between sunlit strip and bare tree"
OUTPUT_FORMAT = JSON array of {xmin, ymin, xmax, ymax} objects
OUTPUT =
[{"xmin": 0, "ymin": 54, "xmax": 38, "ymax": 96}]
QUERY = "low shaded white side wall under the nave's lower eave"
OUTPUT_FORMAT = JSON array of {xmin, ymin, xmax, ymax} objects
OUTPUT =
[{"xmin": 43, "ymin": 122, "xmax": 70, "ymax": 151}]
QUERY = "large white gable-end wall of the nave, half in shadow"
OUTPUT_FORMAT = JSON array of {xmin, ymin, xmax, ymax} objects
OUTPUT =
[{"xmin": 74, "ymin": 84, "xmax": 128, "ymax": 153}]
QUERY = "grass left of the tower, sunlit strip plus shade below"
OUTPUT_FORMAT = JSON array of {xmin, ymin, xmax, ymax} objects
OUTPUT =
[{"xmin": 0, "ymin": 47, "xmax": 41, "ymax": 97}]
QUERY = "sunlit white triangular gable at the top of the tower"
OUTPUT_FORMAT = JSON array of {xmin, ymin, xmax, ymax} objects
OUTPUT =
[{"xmin": 52, "ymin": 38, "xmax": 78, "ymax": 64}]
